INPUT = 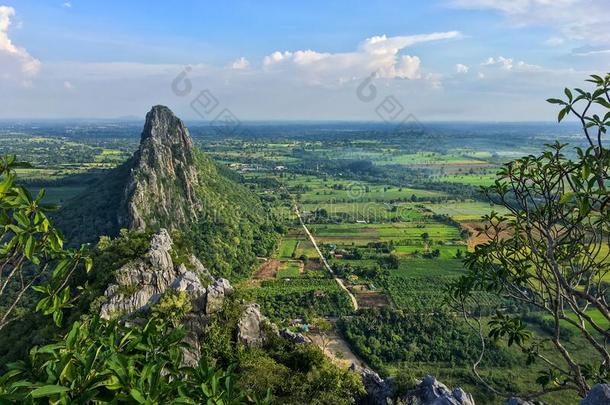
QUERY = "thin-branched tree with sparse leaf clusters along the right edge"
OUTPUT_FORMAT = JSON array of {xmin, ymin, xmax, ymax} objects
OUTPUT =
[{"xmin": 450, "ymin": 74, "xmax": 610, "ymax": 397}]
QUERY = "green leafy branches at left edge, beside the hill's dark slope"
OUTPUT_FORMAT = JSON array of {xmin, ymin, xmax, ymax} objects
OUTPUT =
[{"xmin": 0, "ymin": 156, "xmax": 91, "ymax": 330}]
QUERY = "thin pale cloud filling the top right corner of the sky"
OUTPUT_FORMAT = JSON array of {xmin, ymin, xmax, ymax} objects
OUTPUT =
[{"xmin": 449, "ymin": 0, "xmax": 610, "ymax": 43}]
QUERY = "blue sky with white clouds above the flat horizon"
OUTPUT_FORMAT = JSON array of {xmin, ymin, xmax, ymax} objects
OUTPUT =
[{"xmin": 0, "ymin": 0, "xmax": 610, "ymax": 121}]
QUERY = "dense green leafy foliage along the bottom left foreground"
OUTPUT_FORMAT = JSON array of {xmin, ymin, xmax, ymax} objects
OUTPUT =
[{"xmin": 0, "ymin": 318, "xmax": 270, "ymax": 404}]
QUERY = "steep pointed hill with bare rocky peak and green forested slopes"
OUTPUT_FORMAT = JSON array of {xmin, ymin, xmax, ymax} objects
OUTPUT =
[{"xmin": 56, "ymin": 106, "xmax": 277, "ymax": 277}]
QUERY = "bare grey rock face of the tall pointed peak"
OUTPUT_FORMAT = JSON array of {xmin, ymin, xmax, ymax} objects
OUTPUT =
[{"xmin": 119, "ymin": 106, "xmax": 200, "ymax": 229}]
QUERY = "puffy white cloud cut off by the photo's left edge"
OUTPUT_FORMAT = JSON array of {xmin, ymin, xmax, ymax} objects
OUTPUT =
[{"xmin": 0, "ymin": 6, "xmax": 40, "ymax": 84}]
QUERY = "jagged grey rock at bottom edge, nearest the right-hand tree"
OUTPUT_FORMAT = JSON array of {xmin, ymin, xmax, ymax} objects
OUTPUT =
[{"xmin": 403, "ymin": 375, "xmax": 474, "ymax": 405}]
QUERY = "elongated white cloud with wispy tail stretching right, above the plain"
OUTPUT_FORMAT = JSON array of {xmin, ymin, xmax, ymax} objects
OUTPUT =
[{"xmin": 263, "ymin": 31, "xmax": 461, "ymax": 83}]
